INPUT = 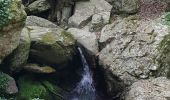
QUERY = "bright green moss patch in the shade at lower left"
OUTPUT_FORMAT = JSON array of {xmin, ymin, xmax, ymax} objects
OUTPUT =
[{"xmin": 17, "ymin": 76, "xmax": 50, "ymax": 100}]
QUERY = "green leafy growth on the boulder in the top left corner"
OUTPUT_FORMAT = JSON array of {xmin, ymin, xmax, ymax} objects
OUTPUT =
[{"xmin": 0, "ymin": 0, "xmax": 12, "ymax": 28}]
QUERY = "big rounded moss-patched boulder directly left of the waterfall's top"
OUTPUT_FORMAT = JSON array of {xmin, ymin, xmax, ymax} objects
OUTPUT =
[{"xmin": 28, "ymin": 26, "xmax": 75, "ymax": 68}]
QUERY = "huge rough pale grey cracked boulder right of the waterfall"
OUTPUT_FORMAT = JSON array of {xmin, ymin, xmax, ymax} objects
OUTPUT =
[{"xmin": 99, "ymin": 16, "xmax": 170, "ymax": 94}]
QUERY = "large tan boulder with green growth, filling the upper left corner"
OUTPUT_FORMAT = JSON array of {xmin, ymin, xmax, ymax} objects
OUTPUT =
[{"xmin": 0, "ymin": 0, "xmax": 26, "ymax": 62}]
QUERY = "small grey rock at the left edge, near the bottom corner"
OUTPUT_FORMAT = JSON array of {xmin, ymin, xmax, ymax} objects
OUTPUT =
[{"xmin": 0, "ymin": 72, "xmax": 18, "ymax": 96}]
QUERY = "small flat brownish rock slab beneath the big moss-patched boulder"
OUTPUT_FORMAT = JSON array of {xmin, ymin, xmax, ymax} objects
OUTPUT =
[{"xmin": 24, "ymin": 64, "xmax": 56, "ymax": 74}]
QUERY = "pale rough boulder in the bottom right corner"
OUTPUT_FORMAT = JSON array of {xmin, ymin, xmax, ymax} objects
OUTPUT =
[{"xmin": 125, "ymin": 77, "xmax": 170, "ymax": 100}]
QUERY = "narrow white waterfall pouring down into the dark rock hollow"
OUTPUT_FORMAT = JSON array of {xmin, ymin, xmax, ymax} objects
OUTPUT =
[{"xmin": 69, "ymin": 47, "xmax": 96, "ymax": 100}]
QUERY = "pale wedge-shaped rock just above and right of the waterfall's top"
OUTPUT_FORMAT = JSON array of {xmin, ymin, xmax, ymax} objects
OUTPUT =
[{"xmin": 68, "ymin": 28, "xmax": 98, "ymax": 68}]
